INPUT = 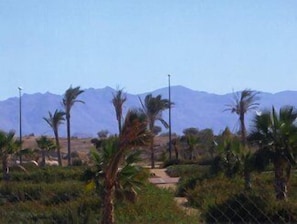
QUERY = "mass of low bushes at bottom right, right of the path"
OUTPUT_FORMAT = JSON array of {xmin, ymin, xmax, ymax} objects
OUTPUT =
[{"xmin": 185, "ymin": 172, "xmax": 297, "ymax": 223}]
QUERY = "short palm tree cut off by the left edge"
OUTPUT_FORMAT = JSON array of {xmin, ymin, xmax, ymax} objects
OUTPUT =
[{"xmin": 0, "ymin": 131, "xmax": 17, "ymax": 180}]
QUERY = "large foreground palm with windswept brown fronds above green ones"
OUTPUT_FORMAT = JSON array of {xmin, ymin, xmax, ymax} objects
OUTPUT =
[{"xmin": 92, "ymin": 110, "xmax": 150, "ymax": 224}]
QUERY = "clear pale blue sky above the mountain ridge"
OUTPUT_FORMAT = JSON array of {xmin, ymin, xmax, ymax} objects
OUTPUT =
[{"xmin": 0, "ymin": 0, "xmax": 297, "ymax": 100}]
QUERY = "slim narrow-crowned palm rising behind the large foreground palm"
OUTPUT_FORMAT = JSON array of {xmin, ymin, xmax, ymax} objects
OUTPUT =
[{"xmin": 112, "ymin": 89, "xmax": 127, "ymax": 135}]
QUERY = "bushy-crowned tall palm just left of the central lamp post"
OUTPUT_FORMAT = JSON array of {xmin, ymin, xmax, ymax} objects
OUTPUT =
[{"xmin": 139, "ymin": 94, "xmax": 172, "ymax": 168}]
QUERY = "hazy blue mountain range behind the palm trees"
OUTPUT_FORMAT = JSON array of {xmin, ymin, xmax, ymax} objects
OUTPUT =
[{"xmin": 0, "ymin": 86, "xmax": 297, "ymax": 137}]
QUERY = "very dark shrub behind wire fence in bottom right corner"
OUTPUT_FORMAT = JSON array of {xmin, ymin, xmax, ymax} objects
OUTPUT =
[{"xmin": 205, "ymin": 192, "xmax": 297, "ymax": 223}]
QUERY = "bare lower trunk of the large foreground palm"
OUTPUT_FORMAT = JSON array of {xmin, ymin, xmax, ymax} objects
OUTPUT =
[{"xmin": 101, "ymin": 179, "xmax": 114, "ymax": 224}]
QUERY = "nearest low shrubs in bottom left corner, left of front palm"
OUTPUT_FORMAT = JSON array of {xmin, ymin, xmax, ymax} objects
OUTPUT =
[{"xmin": 0, "ymin": 195, "xmax": 101, "ymax": 224}]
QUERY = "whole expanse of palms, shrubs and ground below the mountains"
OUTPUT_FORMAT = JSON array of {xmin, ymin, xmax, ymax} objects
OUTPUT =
[{"xmin": 0, "ymin": 87, "xmax": 297, "ymax": 224}]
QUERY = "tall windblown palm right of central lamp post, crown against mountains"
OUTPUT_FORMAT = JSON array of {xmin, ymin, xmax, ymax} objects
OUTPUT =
[{"xmin": 226, "ymin": 89, "xmax": 260, "ymax": 145}]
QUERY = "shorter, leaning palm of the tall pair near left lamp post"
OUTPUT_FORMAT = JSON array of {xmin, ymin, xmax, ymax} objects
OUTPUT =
[{"xmin": 43, "ymin": 110, "xmax": 65, "ymax": 166}]
